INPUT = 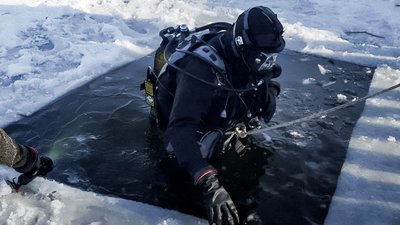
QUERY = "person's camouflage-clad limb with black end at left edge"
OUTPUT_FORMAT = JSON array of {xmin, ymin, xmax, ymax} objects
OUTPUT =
[{"xmin": 0, "ymin": 128, "xmax": 53, "ymax": 192}]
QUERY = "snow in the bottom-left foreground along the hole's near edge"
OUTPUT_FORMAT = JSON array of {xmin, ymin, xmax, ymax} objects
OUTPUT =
[{"xmin": 0, "ymin": 167, "xmax": 205, "ymax": 225}]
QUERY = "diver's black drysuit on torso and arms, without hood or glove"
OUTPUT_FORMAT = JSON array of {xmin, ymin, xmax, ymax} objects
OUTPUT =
[{"xmin": 156, "ymin": 36, "xmax": 279, "ymax": 177}]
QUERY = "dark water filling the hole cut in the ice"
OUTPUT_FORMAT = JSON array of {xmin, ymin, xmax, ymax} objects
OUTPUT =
[{"xmin": 6, "ymin": 51, "xmax": 373, "ymax": 225}]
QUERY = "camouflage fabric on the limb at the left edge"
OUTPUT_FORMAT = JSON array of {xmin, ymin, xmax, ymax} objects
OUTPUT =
[{"xmin": 0, "ymin": 128, "xmax": 28, "ymax": 167}]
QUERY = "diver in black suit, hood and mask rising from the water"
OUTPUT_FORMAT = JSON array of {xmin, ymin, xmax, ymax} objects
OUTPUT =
[{"xmin": 147, "ymin": 6, "xmax": 285, "ymax": 225}]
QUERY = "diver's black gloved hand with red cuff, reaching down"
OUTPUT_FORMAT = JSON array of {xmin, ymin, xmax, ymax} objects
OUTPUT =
[{"xmin": 195, "ymin": 169, "xmax": 239, "ymax": 225}]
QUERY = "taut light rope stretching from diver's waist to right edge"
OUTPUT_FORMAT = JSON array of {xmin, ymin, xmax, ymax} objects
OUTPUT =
[{"xmin": 226, "ymin": 83, "xmax": 400, "ymax": 135}]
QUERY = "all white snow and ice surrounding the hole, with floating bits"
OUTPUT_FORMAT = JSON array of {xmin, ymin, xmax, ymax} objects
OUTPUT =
[{"xmin": 0, "ymin": 0, "xmax": 400, "ymax": 225}]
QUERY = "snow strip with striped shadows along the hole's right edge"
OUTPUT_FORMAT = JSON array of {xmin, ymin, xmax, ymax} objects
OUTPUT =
[{"xmin": 325, "ymin": 67, "xmax": 400, "ymax": 225}]
